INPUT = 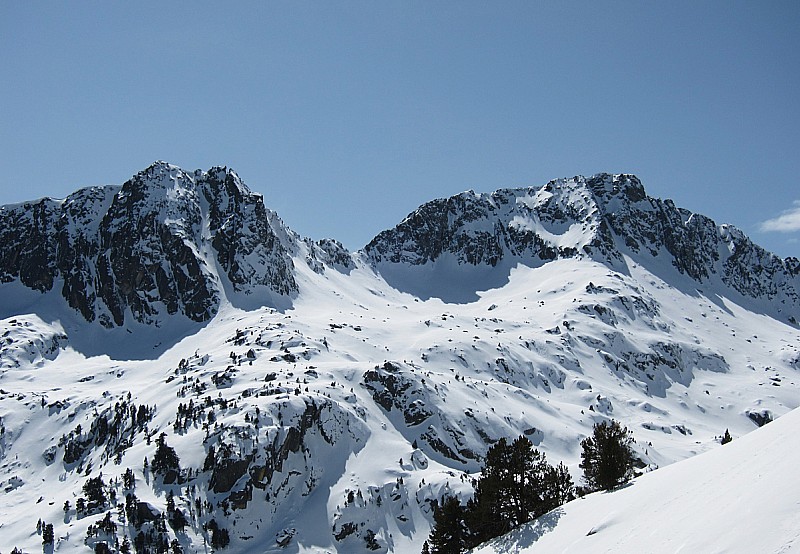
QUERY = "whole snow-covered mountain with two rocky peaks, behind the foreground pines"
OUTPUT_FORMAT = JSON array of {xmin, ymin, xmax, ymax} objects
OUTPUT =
[{"xmin": 0, "ymin": 162, "xmax": 800, "ymax": 553}]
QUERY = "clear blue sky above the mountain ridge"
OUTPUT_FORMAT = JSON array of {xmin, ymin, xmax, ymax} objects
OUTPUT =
[{"xmin": 0, "ymin": 0, "xmax": 800, "ymax": 256}]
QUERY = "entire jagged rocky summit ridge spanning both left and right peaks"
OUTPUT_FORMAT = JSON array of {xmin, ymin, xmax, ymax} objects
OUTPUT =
[{"xmin": 0, "ymin": 161, "xmax": 800, "ymax": 327}]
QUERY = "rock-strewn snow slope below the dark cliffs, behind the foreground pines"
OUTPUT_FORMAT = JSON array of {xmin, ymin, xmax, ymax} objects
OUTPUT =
[{"xmin": 0, "ymin": 252, "xmax": 800, "ymax": 552}]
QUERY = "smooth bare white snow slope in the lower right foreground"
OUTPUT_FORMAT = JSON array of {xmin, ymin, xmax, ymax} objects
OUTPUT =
[{"xmin": 474, "ymin": 402, "xmax": 800, "ymax": 554}]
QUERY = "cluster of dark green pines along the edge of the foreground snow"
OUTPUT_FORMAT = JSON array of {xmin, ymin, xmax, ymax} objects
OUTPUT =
[{"xmin": 422, "ymin": 421, "xmax": 636, "ymax": 554}]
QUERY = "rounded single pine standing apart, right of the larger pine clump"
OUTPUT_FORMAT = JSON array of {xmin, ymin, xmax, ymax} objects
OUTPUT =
[{"xmin": 579, "ymin": 420, "xmax": 636, "ymax": 490}]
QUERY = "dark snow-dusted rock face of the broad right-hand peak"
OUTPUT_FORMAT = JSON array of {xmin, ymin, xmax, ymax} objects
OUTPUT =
[{"xmin": 364, "ymin": 173, "xmax": 800, "ymax": 307}]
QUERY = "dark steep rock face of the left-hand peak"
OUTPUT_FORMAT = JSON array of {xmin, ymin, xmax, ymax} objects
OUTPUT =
[{"xmin": 0, "ymin": 162, "xmax": 297, "ymax": 327}]
